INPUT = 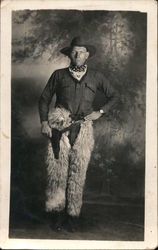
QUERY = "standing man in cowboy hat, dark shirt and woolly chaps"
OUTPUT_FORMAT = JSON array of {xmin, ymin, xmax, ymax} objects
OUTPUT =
[{"xmin": 39, "ymin": 37, "xmax": 117, "ymax": 230}]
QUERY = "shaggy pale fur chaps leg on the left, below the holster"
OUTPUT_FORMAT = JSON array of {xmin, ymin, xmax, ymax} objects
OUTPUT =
[{"xmin": 46, "ymin": 133, "xmax": 70, "ymax": 212}]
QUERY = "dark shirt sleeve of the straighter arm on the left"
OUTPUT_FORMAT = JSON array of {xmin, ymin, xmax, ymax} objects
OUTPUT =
[{"xmin": 39, "ymin": 72, "xmax": 57, "ymax": 122}]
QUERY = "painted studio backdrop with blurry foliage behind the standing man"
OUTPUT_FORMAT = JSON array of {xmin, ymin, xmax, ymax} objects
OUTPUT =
[{"xmin": 10, "ymin": 10, "xmax": 146, "ymax": 240}]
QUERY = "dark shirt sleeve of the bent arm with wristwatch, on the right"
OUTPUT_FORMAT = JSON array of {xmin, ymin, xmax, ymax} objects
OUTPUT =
[{"xmin": 98, "ymin": 73, "xmax": 119, "ymax": 114}]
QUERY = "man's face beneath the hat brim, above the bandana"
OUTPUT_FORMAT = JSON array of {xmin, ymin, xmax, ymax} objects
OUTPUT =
[{"xmin": 70, "ymin": 46, "xmax": 89, "ymax": 66}]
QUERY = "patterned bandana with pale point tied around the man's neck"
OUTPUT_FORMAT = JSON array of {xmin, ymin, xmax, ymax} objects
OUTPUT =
[{"xmin": 69, "ymin": 65, "xmax": 87, "ymax": 81}]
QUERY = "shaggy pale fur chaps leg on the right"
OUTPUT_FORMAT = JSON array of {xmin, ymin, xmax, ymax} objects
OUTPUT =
[{"xmin": 67, "ymin": 121, "xmax": 94, "ymax": 216}]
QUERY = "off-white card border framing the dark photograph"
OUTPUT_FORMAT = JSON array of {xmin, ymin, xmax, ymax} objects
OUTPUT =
[{"xmin": 0, "ymin": 0, "xmax": 157, "ymax": 249}]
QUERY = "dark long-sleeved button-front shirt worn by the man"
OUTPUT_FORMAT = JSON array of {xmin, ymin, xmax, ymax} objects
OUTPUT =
[{"xmin": 39, "ymin": 68, "xmax": 117, "ymax": 122}]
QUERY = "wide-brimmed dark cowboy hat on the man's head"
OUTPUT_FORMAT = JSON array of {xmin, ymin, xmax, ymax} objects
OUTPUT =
[{"xmin": 60, "ymin": 36, "xmax": 96, "ymax": 57}]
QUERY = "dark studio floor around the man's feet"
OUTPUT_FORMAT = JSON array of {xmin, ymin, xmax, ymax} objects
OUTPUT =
[{"xmin": 9, "ymin": 202, "xmax": 144, "ymax": 241}]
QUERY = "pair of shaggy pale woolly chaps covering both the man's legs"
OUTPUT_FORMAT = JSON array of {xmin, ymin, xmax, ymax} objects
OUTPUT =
[{"xmin": 46, "ymin": 108, "xmax": 94, "ymax": 216}]
